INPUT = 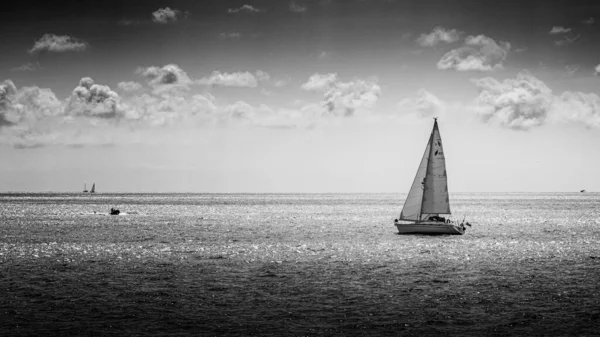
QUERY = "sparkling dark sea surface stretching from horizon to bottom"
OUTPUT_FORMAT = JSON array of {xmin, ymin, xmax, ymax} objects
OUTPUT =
[{"xmin": 0, "ymin": 193, "xmax": 600, "ymax": 336}]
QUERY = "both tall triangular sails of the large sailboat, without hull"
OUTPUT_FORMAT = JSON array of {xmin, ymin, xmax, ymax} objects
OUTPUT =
[{"xmin": 400, "ymin": 119, "xmax": 450, "ymax": 221}]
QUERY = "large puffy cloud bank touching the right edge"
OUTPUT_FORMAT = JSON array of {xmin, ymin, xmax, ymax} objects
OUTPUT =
[{"xmin": 472, "ymin": 71, "xmax": 600, "ymax": 130}]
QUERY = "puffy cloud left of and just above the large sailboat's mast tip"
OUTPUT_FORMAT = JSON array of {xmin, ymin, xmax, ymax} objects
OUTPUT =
[{"xmin": 301, "ymin": 73, "xmax": 381, "ymax": 116}]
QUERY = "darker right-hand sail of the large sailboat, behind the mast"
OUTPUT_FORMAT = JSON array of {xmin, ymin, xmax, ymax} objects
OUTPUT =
[{"xmin": 421, "ymin": 120, "xmax": 450, "ymax": 215}]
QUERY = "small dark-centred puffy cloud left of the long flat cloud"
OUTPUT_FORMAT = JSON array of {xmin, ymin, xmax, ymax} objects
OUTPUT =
[{"xmin": 136, "ymin": 64, "xmax": 192, "ymax": 92}]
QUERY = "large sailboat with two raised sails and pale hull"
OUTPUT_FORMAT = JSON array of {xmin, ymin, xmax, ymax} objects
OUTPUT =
[{"xmin": 394, "ymin": 118, "xmax": 471, "ymax": 235}]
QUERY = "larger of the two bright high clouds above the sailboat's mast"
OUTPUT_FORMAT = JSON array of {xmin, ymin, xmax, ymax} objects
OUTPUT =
[{"xmin": 437, "ymin": 35, "xmax": 510, "ymax": 71}]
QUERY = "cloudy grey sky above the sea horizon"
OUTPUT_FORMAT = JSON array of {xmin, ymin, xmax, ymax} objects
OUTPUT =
[{"xmin": 0, "ymin": 0, "xmax": 600, "ymax": 193}]
